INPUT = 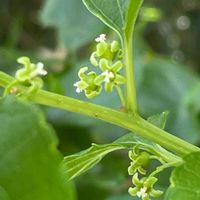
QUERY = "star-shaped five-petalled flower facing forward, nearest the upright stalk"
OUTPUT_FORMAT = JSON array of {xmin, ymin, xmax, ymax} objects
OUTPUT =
[{"xmin": 95, "ymin": 58, "xmax": 125, "ymax": 92}]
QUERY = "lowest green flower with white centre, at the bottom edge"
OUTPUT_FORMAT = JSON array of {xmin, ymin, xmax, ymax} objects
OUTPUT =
[{"xmin": 128, "ymin": 173, "xmax": 163, "ymax": 200}]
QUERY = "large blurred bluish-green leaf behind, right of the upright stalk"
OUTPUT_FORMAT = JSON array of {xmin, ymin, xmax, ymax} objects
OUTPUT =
[{"xmin": 138, "ymin": 58, "xmax": 200, "ymax": 143}]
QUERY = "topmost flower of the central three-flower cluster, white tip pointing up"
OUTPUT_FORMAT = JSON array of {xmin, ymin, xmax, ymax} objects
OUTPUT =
[{"xmin": 90, "ymin": 34, "xmax": 122, "ymax": 66}]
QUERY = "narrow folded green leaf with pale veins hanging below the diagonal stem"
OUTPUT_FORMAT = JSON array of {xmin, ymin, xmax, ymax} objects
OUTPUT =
[{"xmin": 63, "ymin": 133, "xmax": 168, "ymax": 179}]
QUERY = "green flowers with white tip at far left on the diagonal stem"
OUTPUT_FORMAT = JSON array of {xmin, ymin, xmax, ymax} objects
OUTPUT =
[{"xmin": 4, "ymin": 56, "xmax": 47, "ymax": 95}]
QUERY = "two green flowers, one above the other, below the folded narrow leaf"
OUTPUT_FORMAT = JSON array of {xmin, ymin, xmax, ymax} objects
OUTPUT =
[{"xmin": 128, "ymin": 147, "xmax": 163, "ymax": 200}]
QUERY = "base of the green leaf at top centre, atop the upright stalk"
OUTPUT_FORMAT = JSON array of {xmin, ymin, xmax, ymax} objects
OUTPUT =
[{"xmin": 83, "ymin": 0, "xmax": 142, "ymax": 36}]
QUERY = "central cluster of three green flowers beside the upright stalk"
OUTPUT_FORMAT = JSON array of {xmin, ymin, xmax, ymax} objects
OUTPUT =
[{"xmin": 74, "ymin": 34, "xmax": 125, "ymax": 98}]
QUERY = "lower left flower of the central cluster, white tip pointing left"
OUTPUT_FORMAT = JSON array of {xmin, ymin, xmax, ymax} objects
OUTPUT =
[{"xmin": 74, "ymin": 67, "xmax": 102, "ymax": 98}]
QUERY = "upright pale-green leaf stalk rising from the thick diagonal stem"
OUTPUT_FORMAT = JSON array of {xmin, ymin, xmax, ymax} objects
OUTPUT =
[{"xmin": 123, "ymin": 36, "xmax": 138, "ymax": 113}]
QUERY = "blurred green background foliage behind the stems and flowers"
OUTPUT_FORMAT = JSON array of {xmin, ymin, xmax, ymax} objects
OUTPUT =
[{"xmin": 0, "ymin": 0, "xmax": 200, "ymax": 200}]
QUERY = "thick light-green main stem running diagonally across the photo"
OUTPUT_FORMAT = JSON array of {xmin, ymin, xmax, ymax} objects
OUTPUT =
[{"xmin": 0, "ymin": 72, "xmax": 200, "ymax": 156}]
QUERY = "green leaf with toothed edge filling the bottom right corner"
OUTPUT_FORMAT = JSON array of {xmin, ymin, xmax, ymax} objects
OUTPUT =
[{"xmin": 165, "ymin": 152, "xmax": 200, "ymax": 200}]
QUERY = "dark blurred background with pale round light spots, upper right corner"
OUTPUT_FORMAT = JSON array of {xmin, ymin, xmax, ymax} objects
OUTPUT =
[{"xmin": 144, "ymin": 0, "xmax": 200, "ymax": 71}]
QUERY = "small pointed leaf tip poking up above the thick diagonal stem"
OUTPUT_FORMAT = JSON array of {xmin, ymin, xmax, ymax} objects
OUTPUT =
[{"xmin": 147, "ymin": 111, "xmax": 169, "ymax": 129}]
